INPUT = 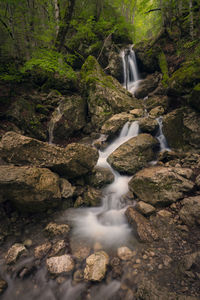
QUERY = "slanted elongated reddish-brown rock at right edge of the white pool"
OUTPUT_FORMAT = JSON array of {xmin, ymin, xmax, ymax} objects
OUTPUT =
[{"xmin": 125, "ymin": 207, "xmax": 159, "ymax": 242}]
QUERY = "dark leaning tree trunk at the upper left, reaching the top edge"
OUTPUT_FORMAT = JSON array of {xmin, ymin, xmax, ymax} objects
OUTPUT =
[{"xmin": 55, "ymin": 0, "xmax": 76, "ymax": 52}]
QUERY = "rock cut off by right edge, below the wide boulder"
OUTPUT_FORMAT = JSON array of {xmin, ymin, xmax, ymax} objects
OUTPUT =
[{"xmin": 179, "ymin": 196, "xmax": 200, "ymax": 226}]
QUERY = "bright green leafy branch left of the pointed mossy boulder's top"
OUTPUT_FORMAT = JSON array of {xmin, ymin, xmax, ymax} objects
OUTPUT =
[{"xmin": 21, "ymin": 49, "xmax": 76, "ymax": 79}]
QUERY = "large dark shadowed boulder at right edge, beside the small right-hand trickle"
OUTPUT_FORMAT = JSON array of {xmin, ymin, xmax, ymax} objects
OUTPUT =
[{"xmin": 163, "ymin": 107, "xmax": 200, "ymax": 150}]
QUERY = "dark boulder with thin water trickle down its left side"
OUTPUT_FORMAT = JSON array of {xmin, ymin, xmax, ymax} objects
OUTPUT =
[{"xmin": 50, "ymin": 95, "xmax": 86, "ymax": 143}]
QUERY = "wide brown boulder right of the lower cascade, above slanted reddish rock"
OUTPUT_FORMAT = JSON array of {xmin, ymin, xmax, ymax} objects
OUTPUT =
[{"xmin": 129, "ymin": 166, "xmax": 194, "ymax": 206}]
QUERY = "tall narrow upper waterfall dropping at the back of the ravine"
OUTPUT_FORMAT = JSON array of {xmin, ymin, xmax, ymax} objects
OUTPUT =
[{"xmin": 121, "ymin": 47, "xmax": 139, "ymax": 94}]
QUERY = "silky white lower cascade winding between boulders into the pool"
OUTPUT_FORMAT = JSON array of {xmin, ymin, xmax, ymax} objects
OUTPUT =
[{"xmin": 71, "ymin": 122, "xmax": 139, "ymax": 246}]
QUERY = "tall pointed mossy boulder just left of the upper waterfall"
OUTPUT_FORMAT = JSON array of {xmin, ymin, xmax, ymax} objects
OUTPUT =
[{"xmin": 81, "ymin": 56, "xmax": 141, "ymax": 128}]
